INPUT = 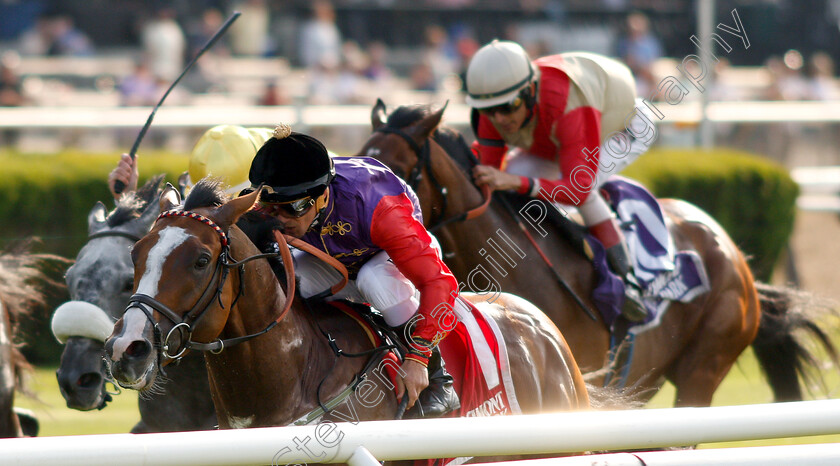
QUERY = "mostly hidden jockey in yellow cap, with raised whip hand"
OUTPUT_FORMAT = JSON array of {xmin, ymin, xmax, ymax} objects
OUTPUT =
[{"xmin": 108, "ymin": 125, "xmax": 272, "ymax": 199}]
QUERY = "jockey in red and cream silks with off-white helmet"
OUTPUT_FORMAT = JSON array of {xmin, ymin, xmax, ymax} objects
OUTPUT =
[{"xmin": 466, "ymin": 40, "xmax": 649, "ymax": 321}]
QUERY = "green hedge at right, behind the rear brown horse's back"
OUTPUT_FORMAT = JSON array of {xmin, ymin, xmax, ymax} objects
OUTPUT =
[{"xmin": 623, "ymin": 149, "xmax": 799, "ymax": 281}]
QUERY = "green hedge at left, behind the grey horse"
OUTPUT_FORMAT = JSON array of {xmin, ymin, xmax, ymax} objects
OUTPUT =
[{"xmin": 0, "ymin": 151, "xmax": 188, "ymax": 365}]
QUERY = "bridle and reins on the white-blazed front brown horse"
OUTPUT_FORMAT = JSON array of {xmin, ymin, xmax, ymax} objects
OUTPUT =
[{"xmin": 126, "ymin": 210, "xmax": 308, "ymax": 364}]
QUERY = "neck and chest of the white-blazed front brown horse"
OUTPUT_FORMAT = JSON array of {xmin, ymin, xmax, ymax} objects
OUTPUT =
[{"xmin": 206, "ymin": 242, "xmax": 354, "ymax": 427}]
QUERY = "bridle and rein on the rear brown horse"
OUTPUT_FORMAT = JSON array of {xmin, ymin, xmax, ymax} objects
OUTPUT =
[{"xmin": 374, "ymin": 126, "xmax": 492, "ymax": 232}]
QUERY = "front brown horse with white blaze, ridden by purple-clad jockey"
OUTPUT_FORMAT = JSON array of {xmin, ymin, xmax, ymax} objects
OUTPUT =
[{"xmin": 105, "ymin": 180, "xmax": 589, "ymax": 440}]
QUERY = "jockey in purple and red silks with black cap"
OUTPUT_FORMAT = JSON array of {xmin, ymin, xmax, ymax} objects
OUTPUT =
[{"xmin": 245, "ymin": 125, "xmax": 459, "ymax": 417}]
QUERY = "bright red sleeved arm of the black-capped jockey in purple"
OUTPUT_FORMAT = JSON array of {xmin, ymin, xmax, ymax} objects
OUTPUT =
[{"xmin": 370, "ymin": 195, "xmax": 458, "ymax": 366}]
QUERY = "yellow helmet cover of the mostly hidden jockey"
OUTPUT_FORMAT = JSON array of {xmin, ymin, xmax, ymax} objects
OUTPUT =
[{"xmin": 187, "ymin": 125, "xmax": 273, "ymax": 194}]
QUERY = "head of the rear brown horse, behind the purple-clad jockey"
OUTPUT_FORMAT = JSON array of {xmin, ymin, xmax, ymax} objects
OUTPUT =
[{"xmin": 359, "ymin": 99, "xmax": 446, "ymax": 190}]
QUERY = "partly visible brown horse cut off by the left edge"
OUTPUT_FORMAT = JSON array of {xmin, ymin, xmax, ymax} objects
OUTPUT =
[{"xmin": 0, "ymin": 244, "xmax": 61, "ymax": 438}]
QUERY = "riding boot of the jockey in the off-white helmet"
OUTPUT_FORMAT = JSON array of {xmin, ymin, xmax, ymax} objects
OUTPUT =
[{"xmin": 589, "ymin": 218, "xmax": 647, "ymax": 322}]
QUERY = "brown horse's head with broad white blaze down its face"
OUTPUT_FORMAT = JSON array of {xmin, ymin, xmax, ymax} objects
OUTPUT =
[{"xmin": 105, "ymin": 179, "xmax": 259, "ymax": 390}]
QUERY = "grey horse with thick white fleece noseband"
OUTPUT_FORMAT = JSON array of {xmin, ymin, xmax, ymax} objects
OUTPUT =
[{"xmin": 52, "ymin": 176, "xmax": 216, "ymax": 433}]
